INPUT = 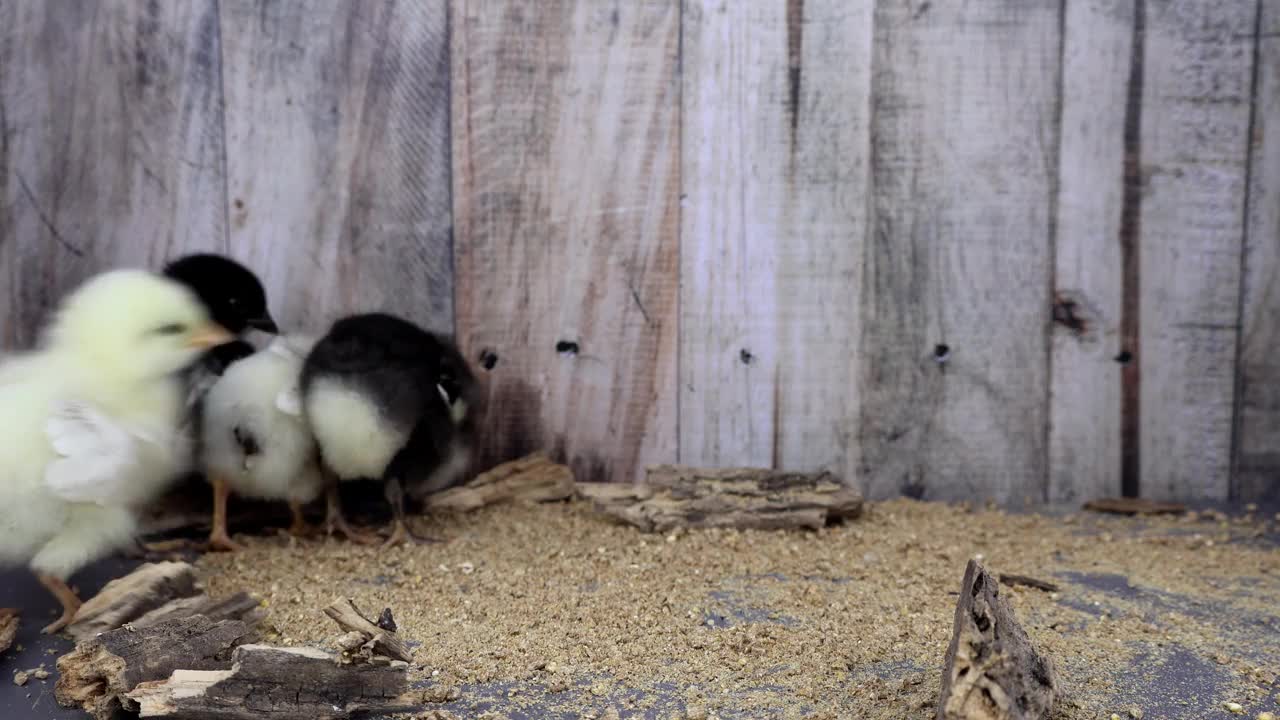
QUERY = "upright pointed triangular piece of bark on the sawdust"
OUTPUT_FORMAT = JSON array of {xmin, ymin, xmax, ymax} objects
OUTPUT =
[{"xmin": 937, "ymin": 560, "xmax": 1057, "ymax": 720}]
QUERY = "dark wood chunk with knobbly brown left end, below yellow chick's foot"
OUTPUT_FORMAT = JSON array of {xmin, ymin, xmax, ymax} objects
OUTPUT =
[{"xmin": 54, "ymin": 615, "xmax": 256, "ymax": 720}]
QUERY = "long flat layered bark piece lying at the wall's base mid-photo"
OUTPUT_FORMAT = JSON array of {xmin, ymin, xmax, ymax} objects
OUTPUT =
[{"xmin": 577, "ymin": 465, "xmax": 863, "ymax": 532}]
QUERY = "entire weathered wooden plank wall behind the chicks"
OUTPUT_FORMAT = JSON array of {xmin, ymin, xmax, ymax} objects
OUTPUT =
[{"xmin": 0, "ymin": 0, "xmax": 1280, "ymax": 502}]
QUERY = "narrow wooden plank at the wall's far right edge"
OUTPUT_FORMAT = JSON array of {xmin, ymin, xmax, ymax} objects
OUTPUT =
[{"xmin": 1234, "ymin": 0, "xmax": 1280, "ymax": 501}]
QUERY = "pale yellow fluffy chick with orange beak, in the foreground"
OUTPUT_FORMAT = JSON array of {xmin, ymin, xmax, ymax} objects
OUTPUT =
[{"xmin": 0, "ymin": 270, "xmax": 230, "ymax": 633}]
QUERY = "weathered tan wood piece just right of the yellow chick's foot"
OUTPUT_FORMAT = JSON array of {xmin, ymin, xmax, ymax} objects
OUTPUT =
[{"xmin": 67, "ymin": 562, "xmax": 265, "ymax": 642}]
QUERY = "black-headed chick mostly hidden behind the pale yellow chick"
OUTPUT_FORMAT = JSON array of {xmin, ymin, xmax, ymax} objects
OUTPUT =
[{"xmin": 163, "ymin": 252, "xmax": 279, "ymax": 469}]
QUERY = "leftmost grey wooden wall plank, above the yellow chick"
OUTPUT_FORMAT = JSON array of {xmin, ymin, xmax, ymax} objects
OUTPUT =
[{"xmin": 0, "ymin": 0, "xmax": 225, "ymax": 347}]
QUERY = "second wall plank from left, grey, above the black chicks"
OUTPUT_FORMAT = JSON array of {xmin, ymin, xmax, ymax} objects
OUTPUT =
[{"xmin": 221, "ymin": 0, "xmax": 453, "ymax": 332}]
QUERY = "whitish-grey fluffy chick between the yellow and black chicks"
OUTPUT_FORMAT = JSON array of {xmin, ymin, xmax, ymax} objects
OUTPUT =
[{"xmin": 201, "ymin": 337, "xmax": 323, "ymax": 551}]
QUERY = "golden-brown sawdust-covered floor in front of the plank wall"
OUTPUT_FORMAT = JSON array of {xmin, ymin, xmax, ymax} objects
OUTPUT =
[{"xmin": 192, "ymin": 500, "xmax": 1280, "ymax": 719}]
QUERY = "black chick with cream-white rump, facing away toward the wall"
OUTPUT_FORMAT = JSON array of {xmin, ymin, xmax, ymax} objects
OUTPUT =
[{"xmin": 300, "ymin": 313, "xmax": 477, "ymax": 546}]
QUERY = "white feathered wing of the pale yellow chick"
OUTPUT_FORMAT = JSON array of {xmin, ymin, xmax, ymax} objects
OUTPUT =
[{"xmin": 45, "ymin": 401, "xmax": 147, "ymax": 506}]
